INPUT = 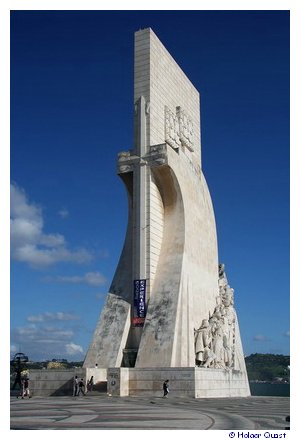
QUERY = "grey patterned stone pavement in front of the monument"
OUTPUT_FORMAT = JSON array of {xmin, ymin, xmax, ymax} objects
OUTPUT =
[{"xmin": 11, "ymin": 394, "xmax": 290, "ymax": 430}]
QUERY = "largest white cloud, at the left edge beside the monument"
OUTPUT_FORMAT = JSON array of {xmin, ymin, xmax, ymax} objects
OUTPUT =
[{"xmin": 10, "ymin": 184, "xmax": 92, "ymax": 268}]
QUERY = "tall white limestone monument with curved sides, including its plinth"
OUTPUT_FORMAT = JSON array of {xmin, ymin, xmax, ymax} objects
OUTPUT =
[{"xmin": 84, "ymin": 28, "xmax": 250, "ymax": 397}]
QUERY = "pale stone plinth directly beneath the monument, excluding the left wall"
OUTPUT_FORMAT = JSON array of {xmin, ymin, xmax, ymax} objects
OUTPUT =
[{"xmin": 107, "ymin": 367, "xmax": 251, "ymax": 398}]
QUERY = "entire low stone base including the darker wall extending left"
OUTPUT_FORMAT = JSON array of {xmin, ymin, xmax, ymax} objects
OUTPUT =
[{"xmin": 29, "ymin": 367, "xmax": 251, "ymax": 398}]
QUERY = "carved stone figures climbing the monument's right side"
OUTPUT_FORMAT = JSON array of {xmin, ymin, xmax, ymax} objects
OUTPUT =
[{"xmin": 194, "ymin": 264, "xmax": 235, "ymax": 368}]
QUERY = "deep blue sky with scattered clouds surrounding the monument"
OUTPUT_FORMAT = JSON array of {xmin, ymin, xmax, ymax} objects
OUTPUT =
[{"xmin": 10, "ymin": 11, "xmax": 290, "ymax": 360}]
